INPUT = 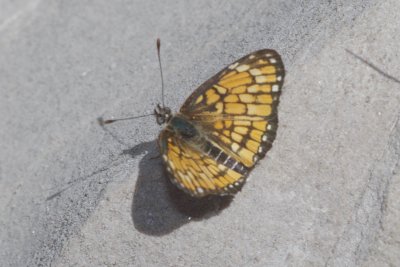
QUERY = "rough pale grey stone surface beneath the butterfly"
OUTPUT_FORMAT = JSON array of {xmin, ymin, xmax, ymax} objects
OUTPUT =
[{"xmin": 0, "ymin": 0, "xmax": 400, "ymax": 266}]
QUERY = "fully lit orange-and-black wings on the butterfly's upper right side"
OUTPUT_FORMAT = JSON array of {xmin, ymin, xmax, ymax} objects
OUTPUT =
[{"xmin": 180, "ymin": 49, "xmax": 285, "ymax": 168}]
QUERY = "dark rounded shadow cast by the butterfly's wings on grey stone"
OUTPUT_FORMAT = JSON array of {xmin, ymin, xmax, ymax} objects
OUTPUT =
[{"xmin": 123, "ymin": 141, "xmax": 233, "ymax": 236}]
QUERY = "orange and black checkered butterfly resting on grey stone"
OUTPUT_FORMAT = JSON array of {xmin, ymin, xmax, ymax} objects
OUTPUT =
[{"xmin": 154, "ymin": 48, "xmax": 285, "ymax": 197}]
